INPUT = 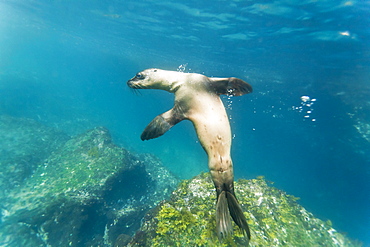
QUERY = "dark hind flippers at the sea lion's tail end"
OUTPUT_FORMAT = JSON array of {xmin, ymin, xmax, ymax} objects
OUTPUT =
[{"xmin": 216, "ymin": 191, "xmax": 251, "ymax": 242}]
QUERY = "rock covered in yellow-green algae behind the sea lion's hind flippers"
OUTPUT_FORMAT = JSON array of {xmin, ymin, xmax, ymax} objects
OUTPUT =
[{"xmin": 127, "ymin": 173, "xmax": 360, "ymax": 247}]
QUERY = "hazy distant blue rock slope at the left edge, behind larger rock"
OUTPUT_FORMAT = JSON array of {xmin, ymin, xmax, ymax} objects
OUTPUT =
[{"xmin": 0, "ymin": 115, "xmax": 69, "ymax": 198}]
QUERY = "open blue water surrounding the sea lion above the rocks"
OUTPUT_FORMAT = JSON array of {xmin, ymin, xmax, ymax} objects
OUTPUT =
[{"xmin": 0, "ymin": 0, "xmax": 370, "ymax": 245}]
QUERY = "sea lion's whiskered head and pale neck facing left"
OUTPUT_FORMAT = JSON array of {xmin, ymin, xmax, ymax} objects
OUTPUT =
[{"xmin": 127, "ymin": 69, "xmax": 178, "ymax": 91}]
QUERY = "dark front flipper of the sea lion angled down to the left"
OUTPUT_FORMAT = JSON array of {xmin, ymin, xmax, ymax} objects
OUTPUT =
[{"xmin": 141, "ymin": 105, "xmax": 184, "ymax": 141}]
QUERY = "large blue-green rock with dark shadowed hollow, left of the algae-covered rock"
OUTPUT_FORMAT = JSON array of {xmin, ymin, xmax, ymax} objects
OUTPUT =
[{"xmin": 0, "ymin": 127, "xmax": 178, "ymax": 247}]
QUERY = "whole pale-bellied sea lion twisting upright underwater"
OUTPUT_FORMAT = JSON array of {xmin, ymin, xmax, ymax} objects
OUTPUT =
[{"xmin": 127, "ymin": 69, "xmax": 252, "ymax": 242}]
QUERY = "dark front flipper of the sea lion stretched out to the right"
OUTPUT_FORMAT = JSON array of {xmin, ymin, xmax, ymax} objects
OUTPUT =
[{"xmin": 209, "ymin": 77, "xmax": 253, "ymax": 96}]
